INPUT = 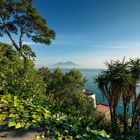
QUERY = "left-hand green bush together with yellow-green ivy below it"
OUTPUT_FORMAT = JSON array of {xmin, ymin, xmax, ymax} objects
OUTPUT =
[{"xmin": 0, "ymin": 43, "xmax": 49, "ymax": 128}]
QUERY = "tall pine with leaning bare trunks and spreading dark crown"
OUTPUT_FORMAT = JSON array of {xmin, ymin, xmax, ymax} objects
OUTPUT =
[{"xmin": 0, "ymin": 0, "xmax": 55, "ymax": 58}]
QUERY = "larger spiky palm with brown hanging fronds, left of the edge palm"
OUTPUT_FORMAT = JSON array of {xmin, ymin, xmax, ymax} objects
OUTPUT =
[{"xmin": 95, "ymin": 59, "xmax": 133, "ymax": 133}]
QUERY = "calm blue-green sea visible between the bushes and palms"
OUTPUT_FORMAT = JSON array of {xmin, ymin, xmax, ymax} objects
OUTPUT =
[{"xmin": 56, "ymin": 69, "xmax": 140, "ymax": 112}]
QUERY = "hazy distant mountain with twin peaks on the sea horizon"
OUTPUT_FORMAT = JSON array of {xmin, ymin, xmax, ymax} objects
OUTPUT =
[{"xmin": 51, "ymin": 61, "xmax": 79, "ymax": 68}]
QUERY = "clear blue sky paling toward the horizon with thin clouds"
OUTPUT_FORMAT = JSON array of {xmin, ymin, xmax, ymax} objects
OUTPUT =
[{"xmin": 1, "ymin": 0, "xmax": 140, "ymax": 68}]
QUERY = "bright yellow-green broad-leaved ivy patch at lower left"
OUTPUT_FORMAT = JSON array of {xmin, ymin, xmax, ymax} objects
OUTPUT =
[{"xmin": 0, "ymin": 94, "xmax": 51, "ymax": 129}]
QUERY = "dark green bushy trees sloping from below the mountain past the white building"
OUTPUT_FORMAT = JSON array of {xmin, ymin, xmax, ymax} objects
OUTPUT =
[{"xmin": 38, "ymin": 68, "xmax": 96, "ymax": 123}]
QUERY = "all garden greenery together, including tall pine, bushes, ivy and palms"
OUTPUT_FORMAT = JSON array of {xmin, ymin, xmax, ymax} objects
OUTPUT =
[{"xmin": 0, "ymin": 0, "xmax": 140, "ymax": 140}]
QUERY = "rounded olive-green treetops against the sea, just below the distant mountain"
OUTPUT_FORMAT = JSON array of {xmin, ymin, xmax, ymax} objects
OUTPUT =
[{"xmin": 37, "ymin": 68, "xmax": 86, "ymax": 97}]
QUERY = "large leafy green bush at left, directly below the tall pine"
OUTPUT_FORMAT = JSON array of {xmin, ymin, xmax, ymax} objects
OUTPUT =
[{"xmin": 0, "ymin": 43, "xmax": 44, "ymax": 99}]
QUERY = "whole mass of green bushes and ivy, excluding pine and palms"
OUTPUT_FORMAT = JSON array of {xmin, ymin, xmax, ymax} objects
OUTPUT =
[{"xmin": 0, "ymin": 43, "xmax": 110, "ymax": 140}]
